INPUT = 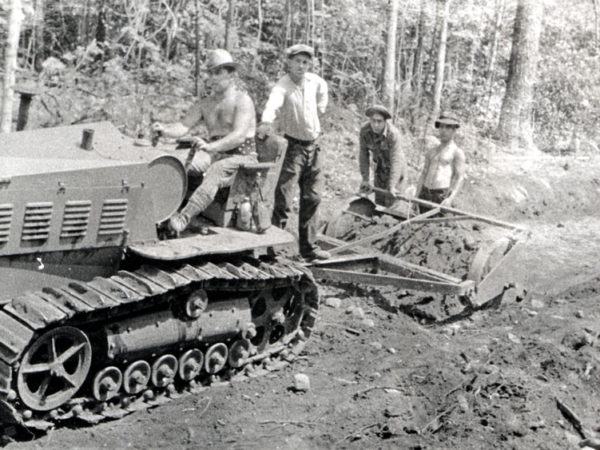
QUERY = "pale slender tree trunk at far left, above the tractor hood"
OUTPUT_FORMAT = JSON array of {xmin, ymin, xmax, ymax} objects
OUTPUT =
[{"xmin": 0, "ymin": 0, "xmax": 23, "ymax": 133}]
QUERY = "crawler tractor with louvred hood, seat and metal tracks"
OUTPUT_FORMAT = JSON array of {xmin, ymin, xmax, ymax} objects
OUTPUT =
[{"xmin": 0, "ymin": 122, "xmax": 319, "ymax": 429}]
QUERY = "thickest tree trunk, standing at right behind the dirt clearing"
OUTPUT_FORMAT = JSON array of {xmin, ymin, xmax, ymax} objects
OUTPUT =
[{"xmin": 497, "ymin": 0, "xmax": 543, "ymax": 148}]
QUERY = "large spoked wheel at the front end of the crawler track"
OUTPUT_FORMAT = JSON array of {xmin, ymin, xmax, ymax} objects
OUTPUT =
[{"xmin": 17, "ymin": 326, "xmax": 92, "ymax": 411}]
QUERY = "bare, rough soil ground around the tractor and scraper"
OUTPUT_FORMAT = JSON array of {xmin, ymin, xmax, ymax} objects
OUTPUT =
[{"xmin": 6, "ymin": 142, "xmax": 600, "ymax": 449}]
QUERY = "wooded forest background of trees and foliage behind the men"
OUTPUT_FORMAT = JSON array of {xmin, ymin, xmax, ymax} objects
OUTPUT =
[{"xmin": 0, "ymin": 0, "xmax": 600, "ymax": 153}]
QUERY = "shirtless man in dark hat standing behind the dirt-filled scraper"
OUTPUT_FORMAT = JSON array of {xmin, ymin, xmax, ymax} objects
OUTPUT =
[{"xmin": 417, "ymin": 113, "xmax": 465, "ymax": 210}]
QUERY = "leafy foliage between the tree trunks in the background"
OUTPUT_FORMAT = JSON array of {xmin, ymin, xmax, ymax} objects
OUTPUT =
[{"xmin": 0, "ymin": 0, "xmax": 600, "ymax": 150}]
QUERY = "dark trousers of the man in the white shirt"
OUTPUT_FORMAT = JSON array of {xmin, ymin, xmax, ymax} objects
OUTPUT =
[{"xmin": 273, "ymin": 136, "xmax": 323, "ymax": 257}]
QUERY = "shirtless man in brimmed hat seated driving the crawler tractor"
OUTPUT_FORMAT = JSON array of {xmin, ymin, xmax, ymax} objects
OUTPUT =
[{"xmin": 153, "ymin": 49, "xmax": 257, "ymax": 233}]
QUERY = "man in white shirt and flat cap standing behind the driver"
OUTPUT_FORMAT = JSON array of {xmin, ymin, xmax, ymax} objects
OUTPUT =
[{"xmin": 257, "ymin": 44, "xmax": 330, "ymax": 261}]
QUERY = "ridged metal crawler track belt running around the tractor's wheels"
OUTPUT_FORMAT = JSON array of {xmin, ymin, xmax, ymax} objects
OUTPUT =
[{"xmin": 0, "ymin": 258, "xmax": 319, "ymax": 429}]
